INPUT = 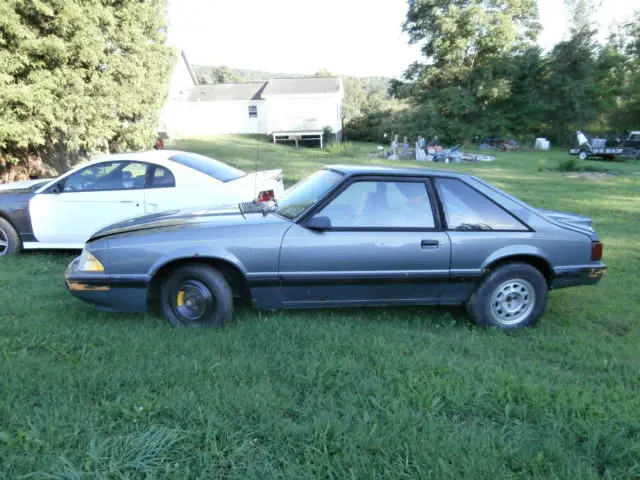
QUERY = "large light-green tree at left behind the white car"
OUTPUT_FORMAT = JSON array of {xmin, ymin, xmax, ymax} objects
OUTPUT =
[{"xmin": 0, "ymin": 0, "xmax": 175, "ymax": 178}]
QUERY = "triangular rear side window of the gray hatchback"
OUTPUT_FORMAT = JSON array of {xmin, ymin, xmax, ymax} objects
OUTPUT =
[{"xmin": 435, "ymin": 178, "xmax": 528, "ymax": 232}]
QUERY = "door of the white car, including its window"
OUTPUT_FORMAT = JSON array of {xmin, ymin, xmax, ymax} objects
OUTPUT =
[{"xmin": 29, "ymin": 161, "xmax": 147, "ymax": 248}]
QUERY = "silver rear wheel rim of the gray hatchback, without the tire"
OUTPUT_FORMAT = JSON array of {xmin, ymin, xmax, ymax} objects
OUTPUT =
[{"xmin": 491, "ymin": 278, "xmax": 536, "ymax": 325}]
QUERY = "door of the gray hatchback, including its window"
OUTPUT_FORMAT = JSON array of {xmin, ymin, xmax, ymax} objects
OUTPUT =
[{"xmin": 279, "ymin": 177, "xmax": 451, "ymax": 307}]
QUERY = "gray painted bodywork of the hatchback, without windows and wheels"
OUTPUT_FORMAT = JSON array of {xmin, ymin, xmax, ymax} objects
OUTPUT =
[{"xmin": 67, "ymin": 166, "xmax": 604, "ymax": 316}]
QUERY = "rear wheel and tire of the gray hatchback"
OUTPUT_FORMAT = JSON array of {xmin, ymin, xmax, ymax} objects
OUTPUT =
[{"xmin": 466, "ymin": 262, "xmax": 549, "ymax": 330}]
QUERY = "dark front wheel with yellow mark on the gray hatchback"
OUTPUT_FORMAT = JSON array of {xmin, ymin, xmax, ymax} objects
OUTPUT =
[{"xmin": 160, "ymin": 264, "xmax": 233, "ymax": 327}]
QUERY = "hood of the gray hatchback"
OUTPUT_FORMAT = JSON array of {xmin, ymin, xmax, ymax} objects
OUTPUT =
[{"xmin": 89, "ymin": 206, "xmax": 282, "ymax": 241}]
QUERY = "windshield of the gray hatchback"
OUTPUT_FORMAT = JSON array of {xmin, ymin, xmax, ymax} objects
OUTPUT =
[{"xmin": 276, "ymin": 170, "xmax": 342, "ymax": 220}]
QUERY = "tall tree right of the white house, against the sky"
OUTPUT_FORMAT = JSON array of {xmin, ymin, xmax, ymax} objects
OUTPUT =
[{"xmin": 391, "ymin": 0, "xmax": 540, "ymax": 140}]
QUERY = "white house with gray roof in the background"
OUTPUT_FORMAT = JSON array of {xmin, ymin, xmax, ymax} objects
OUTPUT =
[{"xmin": 161, "ymin": 54, "xmax": 344, "ymax": 142}]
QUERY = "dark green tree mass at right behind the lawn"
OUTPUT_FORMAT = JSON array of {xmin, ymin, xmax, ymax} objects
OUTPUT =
[{"xmin": 350, "ymin": 0, "xmax": 640, "ymax": 145}]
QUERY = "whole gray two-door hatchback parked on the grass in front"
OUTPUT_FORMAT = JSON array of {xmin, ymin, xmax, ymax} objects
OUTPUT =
[{"xmin": 66, "ymin": 165, "xmax": 606, "ymax": 329}]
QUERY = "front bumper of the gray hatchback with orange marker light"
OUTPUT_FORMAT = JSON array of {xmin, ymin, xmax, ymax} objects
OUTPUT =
[{"xmin": 65, "ymin": 257, "xmax": 149, "ymax": 312}]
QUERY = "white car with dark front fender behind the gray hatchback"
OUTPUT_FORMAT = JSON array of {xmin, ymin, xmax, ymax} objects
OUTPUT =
[{"xmin": 0, "ymin": 150, "xmax": 284, "ymax": 256}]
